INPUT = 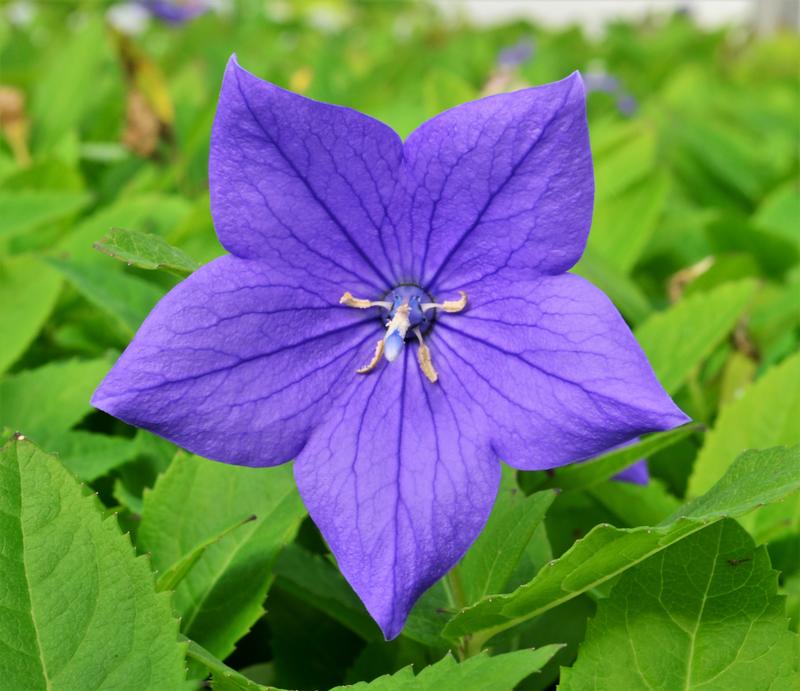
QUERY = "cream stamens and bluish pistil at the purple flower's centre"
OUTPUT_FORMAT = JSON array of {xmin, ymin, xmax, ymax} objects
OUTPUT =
[{"xmin": 339, "ymin": 283, "xmax": 467, "ymax": 383}]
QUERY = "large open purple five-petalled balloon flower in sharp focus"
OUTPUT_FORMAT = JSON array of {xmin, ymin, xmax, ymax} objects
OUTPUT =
[{"xmin": 93, "ymin": 58, "xmax": 687, "ymax": 638}]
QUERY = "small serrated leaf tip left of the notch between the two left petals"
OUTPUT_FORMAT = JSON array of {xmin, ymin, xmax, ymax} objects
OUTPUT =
[{"xmin": 94, "ymin": 228, "xmax": 200, "ymax": 276}]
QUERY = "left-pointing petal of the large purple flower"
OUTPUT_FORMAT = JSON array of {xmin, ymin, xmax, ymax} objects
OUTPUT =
[{"xmin": 92, "ymin": 256, "xmax": 381, "ymax": 466}]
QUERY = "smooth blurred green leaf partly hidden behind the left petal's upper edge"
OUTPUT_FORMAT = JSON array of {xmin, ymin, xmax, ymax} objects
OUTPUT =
[{"xmin": 48, "ymin": 259, "xmax": 164, "ymax": 335}]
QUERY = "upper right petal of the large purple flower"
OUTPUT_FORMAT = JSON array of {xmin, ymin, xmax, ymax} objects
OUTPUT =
[{"xmin": 396, "ymin": 72, "xmax": 594, "ymax": 294}]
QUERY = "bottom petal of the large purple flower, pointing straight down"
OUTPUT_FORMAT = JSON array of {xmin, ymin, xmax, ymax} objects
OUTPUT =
[{"xmin": 295, "ymin": 348, "xmax": 500, "ymax": 639}]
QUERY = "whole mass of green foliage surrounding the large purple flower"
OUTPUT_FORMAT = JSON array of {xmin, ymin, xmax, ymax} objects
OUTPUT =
[{"xmin": 0, "ymin": 1, "xmax": 800, "ymax": 691}]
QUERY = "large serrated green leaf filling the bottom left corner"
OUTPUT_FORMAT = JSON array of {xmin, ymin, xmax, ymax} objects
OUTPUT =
[{"xmin": 0, "ymin": 439, "xmax": 184, "ymax": 691}]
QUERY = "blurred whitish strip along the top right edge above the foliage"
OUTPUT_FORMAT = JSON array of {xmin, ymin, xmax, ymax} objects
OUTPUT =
[{"xmin": 434, "ymin": 0, "xmax": 800, "ymax": 36}]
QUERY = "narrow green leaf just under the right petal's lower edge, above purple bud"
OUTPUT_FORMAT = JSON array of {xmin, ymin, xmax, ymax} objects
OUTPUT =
[{"xmin": 537, "ymin": 424, "xmax": 702, "ymax": 491}]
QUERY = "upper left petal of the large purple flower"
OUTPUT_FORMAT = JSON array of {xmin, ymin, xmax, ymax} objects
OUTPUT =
[{"xmin": 209, "ymin": 57, "xmax": 402, "ymax": 293}]
